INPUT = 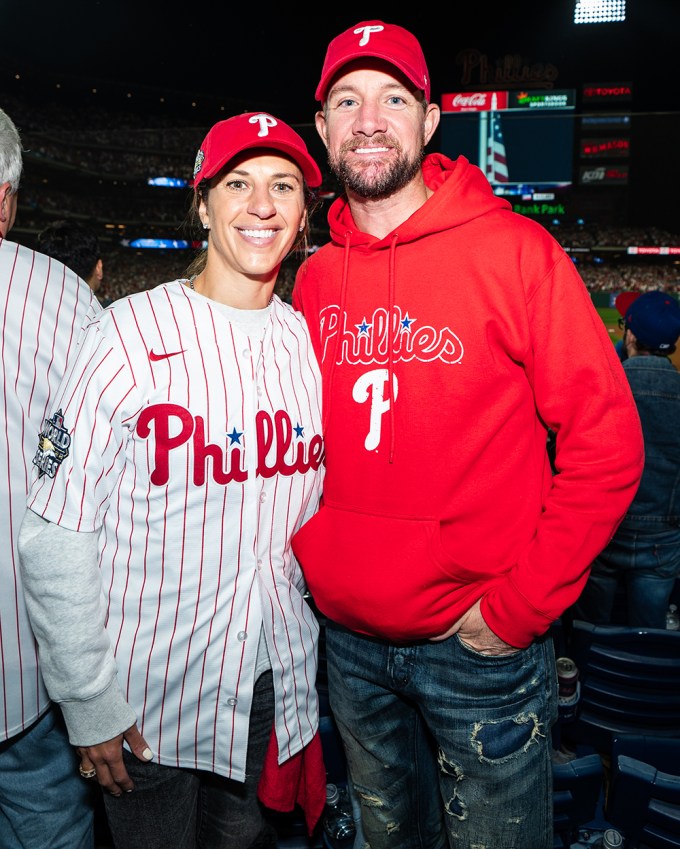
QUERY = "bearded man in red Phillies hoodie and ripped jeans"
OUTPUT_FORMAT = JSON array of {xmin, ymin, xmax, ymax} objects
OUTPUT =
[{"xmin": 293, "ymin": 21, "xmax": 643, "ymax": 849}]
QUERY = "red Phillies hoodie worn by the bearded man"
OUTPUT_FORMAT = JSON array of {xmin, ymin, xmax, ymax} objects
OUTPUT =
[{"xmin": 293, "ymin": 154, "xmax": 643, "ymax": 647}]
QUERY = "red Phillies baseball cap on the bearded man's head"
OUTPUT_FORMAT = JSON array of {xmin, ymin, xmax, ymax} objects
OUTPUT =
[{"xmin": 315, "ymin": 21, "xmax": 430, "ymax": 101}]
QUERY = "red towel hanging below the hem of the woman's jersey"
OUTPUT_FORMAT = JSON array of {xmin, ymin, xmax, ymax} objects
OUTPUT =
[{"xmin": 257, "ymin": 729, "xmax": 326, "ymax": 835}]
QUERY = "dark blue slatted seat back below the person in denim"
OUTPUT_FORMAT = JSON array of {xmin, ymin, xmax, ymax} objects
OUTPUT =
[{"xmin": 563, "ymin": 620, "xmax": 680, "ymax": 754}]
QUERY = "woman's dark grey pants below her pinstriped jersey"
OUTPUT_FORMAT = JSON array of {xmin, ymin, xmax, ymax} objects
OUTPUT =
[{"xmin": 104, "ymin": 671, "xmax": 276, "ymax": 849}]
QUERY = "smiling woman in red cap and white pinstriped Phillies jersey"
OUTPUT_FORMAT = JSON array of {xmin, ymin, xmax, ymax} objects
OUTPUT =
[{"xmin": 19, "ymin": 112, "xmax": 325, "ymax": 849}]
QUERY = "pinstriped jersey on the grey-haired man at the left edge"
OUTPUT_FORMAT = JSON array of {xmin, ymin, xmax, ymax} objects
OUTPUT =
[{"xmin": 0, "ymin": 237, "xmax": 101, "ymax": 740}]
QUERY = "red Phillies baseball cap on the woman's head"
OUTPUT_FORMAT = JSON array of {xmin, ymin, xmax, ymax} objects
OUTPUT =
[{"xmin": 194, "ymin": 112, "xmax": 321, "ymax": 191}]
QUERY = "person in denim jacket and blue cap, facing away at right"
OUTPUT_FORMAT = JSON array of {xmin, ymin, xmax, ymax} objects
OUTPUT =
[{"xmin": 570, "ymin": 291, "xmax": 680, "ymax": 628}]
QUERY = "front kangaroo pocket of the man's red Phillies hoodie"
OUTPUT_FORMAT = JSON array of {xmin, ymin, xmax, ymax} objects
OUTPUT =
[{"xmin": 293, "ymin": 504, "xmax": 488, "ymax": 641}]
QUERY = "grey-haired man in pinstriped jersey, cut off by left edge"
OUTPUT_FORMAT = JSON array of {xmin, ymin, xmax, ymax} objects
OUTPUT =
[{"xmin": 0, "ymin": 110, "xmax": 100, "ymax": 849}]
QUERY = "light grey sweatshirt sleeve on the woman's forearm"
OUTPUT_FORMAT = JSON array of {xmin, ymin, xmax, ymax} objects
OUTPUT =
[{"xmin": 18, "ymin": 510, "xmax": 136, "ymax": 746}]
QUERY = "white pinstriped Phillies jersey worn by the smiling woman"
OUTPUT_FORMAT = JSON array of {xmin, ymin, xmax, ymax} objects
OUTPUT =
[{"xmin": 28, "ymin": 281, "xmax": 324, "ymax": 781}]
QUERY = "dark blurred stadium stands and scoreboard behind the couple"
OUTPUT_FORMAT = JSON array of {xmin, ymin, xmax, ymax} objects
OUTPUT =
[{"xmin": 0, "ymin": 0, "xmax": 680, "ymax": 306}]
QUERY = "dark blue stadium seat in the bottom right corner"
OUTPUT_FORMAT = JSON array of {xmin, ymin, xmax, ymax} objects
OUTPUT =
[{"xmin": 606, "ymin": 734, "xmax": 680, "ymax": 849}]
